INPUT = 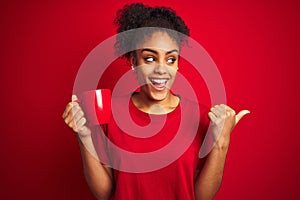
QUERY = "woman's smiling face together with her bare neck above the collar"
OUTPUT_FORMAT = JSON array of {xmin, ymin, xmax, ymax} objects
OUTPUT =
[{"xmin": 130, "ymin": 32, "xmax": 179, "ymax": 114}]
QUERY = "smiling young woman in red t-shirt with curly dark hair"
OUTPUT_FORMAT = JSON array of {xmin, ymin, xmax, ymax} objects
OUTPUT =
[{"xmin": 63, "ymin": 4, "xmax": 249, "ymax": 200}]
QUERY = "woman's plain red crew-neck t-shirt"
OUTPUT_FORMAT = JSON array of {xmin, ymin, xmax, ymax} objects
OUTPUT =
[{"xmin": 96, "ymin": 95, "xmax": 209, "ymax": 200}]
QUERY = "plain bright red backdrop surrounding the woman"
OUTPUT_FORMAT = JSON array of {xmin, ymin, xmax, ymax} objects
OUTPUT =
[{"xmin": 0, "ymin": 0, "xmax": 300, "ymax": 200}]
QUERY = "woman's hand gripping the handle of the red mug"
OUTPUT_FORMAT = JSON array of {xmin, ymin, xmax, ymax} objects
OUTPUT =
[{"xmin": 62, "ymin": 95, "xmax": 91, "ymax": 137}]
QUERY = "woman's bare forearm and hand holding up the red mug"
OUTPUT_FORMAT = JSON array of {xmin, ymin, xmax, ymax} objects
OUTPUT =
[{"xmin": 62, "ymin": 95, "xmax": 113, "ymax": 200}]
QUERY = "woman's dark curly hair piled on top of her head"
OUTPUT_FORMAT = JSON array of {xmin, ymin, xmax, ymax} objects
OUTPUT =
[{"xmin": 114, "ymin": 3, "xmax": 190, "ymax": 58}]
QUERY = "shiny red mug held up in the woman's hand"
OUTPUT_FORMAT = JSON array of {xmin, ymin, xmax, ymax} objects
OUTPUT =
[{"xmin": 79, "ymin": 89, "xmax": 111, "ymax": 125}]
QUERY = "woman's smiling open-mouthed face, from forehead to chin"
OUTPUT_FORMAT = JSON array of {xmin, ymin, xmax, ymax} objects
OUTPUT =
[{"xmin": 131, "ymin": 32, "xmax": 179, "ymax": 101}]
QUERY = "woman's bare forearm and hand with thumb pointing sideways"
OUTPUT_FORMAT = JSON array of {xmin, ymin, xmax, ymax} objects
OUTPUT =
[{"xmin": 195, "ymin": 104, "xmax": 249, "ymax": 200}]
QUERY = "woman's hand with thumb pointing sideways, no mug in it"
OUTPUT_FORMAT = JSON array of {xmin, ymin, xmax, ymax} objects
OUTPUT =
[{"xmin": 208, "ymin": 104, "xmax": 250, "ymax": 148}]
